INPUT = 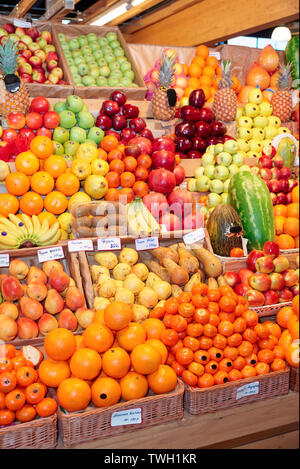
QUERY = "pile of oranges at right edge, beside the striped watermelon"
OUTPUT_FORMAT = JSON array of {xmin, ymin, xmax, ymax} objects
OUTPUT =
[{"xmin": 274, "ymin": 191, "xmax": 299, "ymax": 249}]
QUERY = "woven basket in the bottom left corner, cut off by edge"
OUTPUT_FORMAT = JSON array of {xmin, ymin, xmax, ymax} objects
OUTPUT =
[{"xmin": 0, "ymin": 413, "xmax": 57, "ymax": 449}]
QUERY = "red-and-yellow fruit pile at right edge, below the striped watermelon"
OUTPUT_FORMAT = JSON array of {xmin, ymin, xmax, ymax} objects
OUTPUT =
[{"xmin": 224, "ymin": 241, "xmax": 299, "ymax": 307}]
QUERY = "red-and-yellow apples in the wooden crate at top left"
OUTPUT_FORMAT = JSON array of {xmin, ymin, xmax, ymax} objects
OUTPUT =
[{"xmin": 0, "ymin": 23, "xmax": 67, "ymax": 85}]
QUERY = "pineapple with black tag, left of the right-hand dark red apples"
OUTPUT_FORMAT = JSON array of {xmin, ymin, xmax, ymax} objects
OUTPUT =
[{"xmin": 152, "ymin": 55, "xmax": 177, "ymax": 121}]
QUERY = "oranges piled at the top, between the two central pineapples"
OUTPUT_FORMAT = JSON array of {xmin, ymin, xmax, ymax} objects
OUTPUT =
[{"xmin": 184, "ymin": 44, "xmax": 242, "ymax": 103}]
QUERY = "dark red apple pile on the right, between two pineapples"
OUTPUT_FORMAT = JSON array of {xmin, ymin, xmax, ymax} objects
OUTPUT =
[{"xmin": 175, "ymin": 89, "xmax": 232, "ymax": 158}]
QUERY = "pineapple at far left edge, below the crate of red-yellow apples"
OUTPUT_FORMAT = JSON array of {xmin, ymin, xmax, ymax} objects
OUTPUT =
[{"xmin": 0, "ymin": 39, "xmax": 29, "ymax": 118}]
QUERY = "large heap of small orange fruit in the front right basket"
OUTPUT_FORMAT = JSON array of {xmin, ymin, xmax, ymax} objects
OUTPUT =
[{"xmin": 146, "ymin": 283, "xmax": 292, "ymax": 388}]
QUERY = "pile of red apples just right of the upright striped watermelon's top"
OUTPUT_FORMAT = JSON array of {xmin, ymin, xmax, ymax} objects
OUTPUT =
[{"xmin": 256, "ymin": 145, "xmax": 298, "ymax": 205}]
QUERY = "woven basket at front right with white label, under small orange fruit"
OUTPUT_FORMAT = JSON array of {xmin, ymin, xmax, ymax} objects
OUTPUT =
[{"xmin": 184, "ymin": 368, "xmax": 290, "ymax": 415}]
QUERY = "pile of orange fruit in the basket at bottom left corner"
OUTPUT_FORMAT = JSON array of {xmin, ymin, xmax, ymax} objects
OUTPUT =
[{"xmin": 0, "ymin": 344, "xmax": 57, "ymax": 427}]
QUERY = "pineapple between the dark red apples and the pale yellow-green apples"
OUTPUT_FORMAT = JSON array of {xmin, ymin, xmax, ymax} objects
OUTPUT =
[{"xmin": 212, "ymin": 60, "xmax": 237, "ymax": 122}]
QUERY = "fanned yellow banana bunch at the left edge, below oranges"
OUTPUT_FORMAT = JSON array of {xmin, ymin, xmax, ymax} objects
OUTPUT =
[{"xmin": 0, "ymin": 213, "xmax": 61, "ymax": 250}]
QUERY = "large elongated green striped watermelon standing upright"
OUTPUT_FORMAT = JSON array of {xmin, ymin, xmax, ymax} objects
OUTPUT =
[{"xmin": 228, "ymin": 171, "xmax": 275, "ymax": 251}]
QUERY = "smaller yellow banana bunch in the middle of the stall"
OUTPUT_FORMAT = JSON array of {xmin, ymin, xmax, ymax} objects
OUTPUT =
[{"xmin": 127, "ymin": 198, "xmax": 160, "ymax": 237}]
